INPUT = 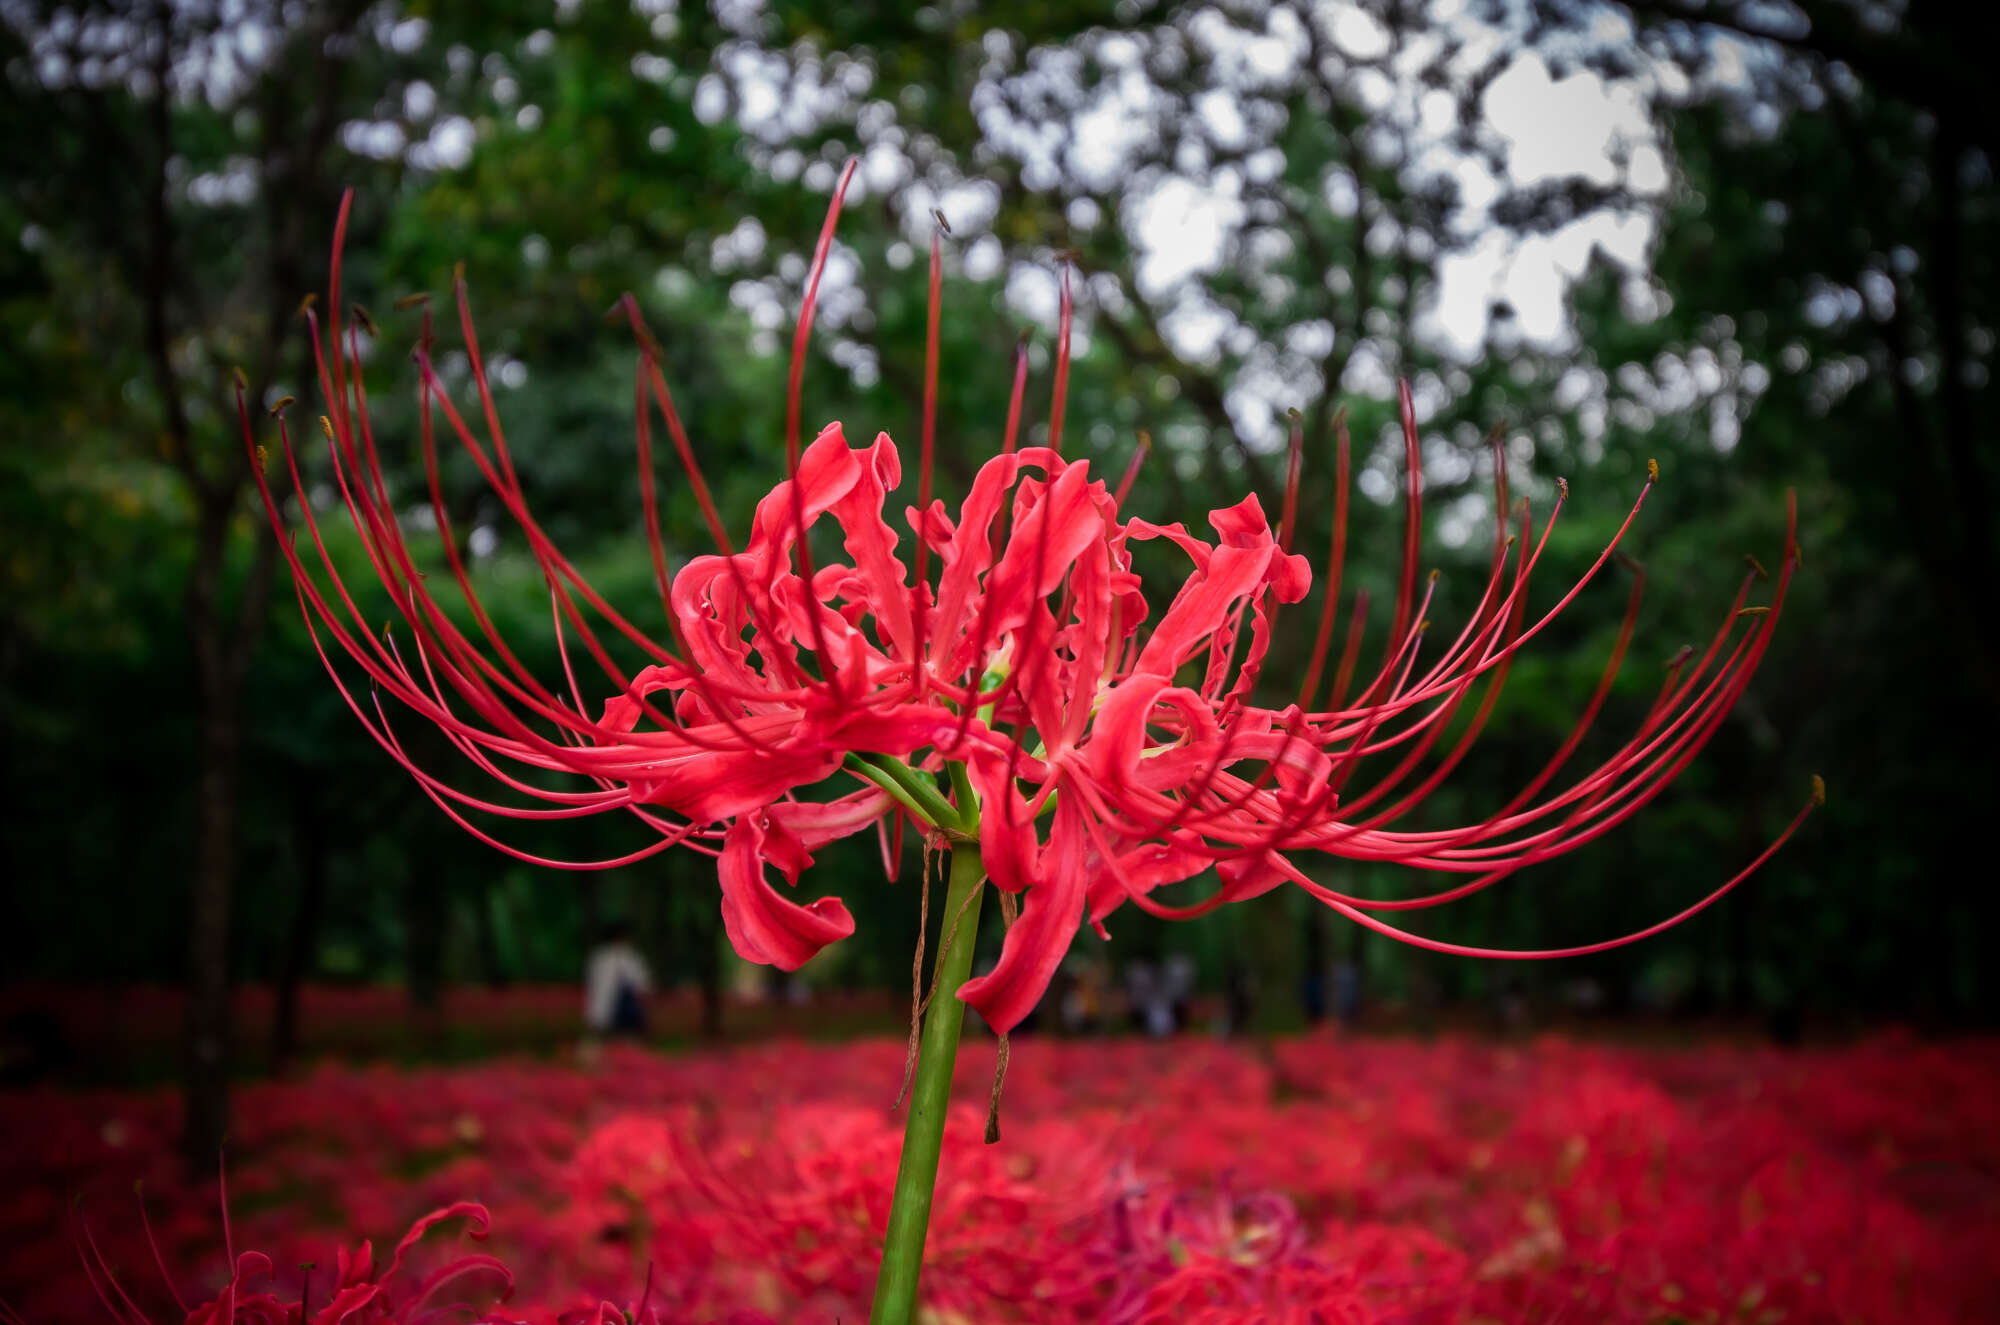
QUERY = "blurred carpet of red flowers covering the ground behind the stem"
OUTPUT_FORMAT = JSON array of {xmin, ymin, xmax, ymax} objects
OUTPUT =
[{"xmin": 0, "ymin": 1037, "xmax": 2000, "ymax": 1325}]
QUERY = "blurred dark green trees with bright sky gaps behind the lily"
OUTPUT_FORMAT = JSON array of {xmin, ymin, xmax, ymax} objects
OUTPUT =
[{"xmin": 0, "ymin": 0, "xmax": 2000, "ymax": 1153}]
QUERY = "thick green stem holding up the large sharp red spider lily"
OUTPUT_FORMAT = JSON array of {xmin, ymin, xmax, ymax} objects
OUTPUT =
[{"xmin": 868, "ymin": 841, "xmax": 986, "ymax": 1325}]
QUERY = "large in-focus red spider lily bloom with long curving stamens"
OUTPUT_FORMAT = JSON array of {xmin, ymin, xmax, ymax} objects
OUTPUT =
[{"xmin": 244, "ymin": 164, "xmax": 1820, "ymax": 1031}]
